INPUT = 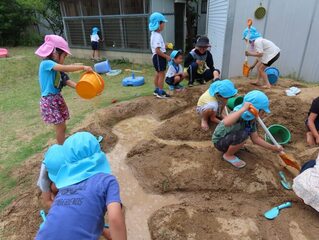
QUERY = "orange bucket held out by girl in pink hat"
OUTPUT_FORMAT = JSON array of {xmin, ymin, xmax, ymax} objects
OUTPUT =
[{"xmin": 76, "ymin": 72, "xmax": 104, "ymax": 99}]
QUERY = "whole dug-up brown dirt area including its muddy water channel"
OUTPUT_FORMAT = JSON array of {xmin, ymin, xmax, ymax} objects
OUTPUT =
[{"xmin": 0, "ymin": 79, "xmax": 319, "ymax": 240}]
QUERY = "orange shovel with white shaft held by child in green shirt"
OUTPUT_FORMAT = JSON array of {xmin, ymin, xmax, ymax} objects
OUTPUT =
[{"xmin": 249, "ymin": 105, "xmax": 300, "ymax": 175}]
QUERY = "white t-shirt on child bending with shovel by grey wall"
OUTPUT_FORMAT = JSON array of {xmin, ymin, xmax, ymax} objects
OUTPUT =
[{"xmin": 254, "ymin": 38, "xmax": 280, "ymax": 64}]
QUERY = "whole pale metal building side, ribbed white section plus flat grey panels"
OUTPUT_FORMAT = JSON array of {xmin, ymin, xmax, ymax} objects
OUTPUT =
[{"xmin": 206, "ymin": 0, "xmax": 319, "ymax": 82}]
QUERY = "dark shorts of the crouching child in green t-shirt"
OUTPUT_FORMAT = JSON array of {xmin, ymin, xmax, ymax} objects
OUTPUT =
[{"xmin": 214, "ymin": 130, "xmax": 250, "ymax": 153}]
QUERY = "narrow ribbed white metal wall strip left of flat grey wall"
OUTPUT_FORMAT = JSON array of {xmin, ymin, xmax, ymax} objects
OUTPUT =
[{"xmin": 206, "ymin": 0, "xmax": 229, "ymax": 69}]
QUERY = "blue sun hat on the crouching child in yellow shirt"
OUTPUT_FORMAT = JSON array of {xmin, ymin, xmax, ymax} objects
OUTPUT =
[{"xmin": 209, "ymin": 79, "xmax": 238, "ymax": 98}]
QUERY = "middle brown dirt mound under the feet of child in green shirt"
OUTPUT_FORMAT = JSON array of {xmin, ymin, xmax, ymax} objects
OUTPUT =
[{"xmin": 127, "ymin": 140, "xmax": 279, "ymax": 194}]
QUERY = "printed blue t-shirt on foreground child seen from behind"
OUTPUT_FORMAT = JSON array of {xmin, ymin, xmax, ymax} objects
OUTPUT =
[{"xmin": 36, "ymin": 173, "xmax": 121, "ymax": 240}]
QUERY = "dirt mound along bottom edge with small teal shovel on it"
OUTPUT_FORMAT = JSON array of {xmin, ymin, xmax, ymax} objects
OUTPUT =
[{"xmin": 149, "ymin": 194, "xmax": 319, "ymax": 240}]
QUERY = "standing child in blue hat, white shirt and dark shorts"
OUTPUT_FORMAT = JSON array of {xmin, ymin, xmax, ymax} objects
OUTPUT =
[{"xmin": 148, "ymin": 12, "xmax": 170, "ymax": 98}]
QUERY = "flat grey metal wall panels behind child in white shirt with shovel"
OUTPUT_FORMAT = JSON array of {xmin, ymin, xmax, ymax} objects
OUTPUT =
[{"xmin": 225, "ymin": 0, "xmax": 319, "ymax": 82}]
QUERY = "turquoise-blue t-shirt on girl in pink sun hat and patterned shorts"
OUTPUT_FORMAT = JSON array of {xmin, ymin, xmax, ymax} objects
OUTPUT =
[{"xmin": 39, "ymin": 60, "xmax": 60, "ymax": 97}]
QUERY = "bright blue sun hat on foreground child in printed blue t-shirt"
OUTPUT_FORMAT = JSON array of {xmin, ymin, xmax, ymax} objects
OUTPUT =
[{"xmin": 55, "ymin": 132, "xmax": 111, "ymax": 189}]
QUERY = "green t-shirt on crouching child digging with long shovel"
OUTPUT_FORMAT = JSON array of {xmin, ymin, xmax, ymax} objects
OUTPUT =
[{"xmin": 212, "ymin": 118, "xmax": 257, "ymax": 143}]
